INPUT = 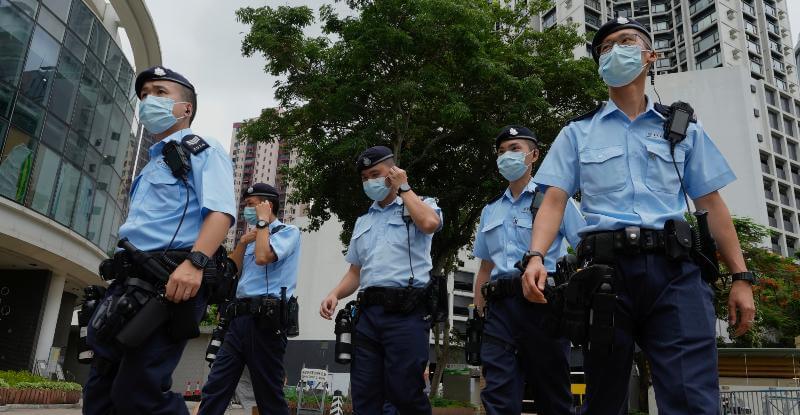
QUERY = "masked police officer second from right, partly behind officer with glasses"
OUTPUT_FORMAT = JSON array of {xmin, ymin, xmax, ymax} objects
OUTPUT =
[{"xmin": 473, "ymin": 125, "xmax": 586, "ymax": 415}]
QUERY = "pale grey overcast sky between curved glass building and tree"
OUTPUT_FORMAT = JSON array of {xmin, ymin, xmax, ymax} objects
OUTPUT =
[{"xmin": 140, "ymin": 0, "xmax": 800, "ymax": 154}]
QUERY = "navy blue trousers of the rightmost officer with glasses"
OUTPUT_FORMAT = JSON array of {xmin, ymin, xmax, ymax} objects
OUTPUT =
[{"xmin": 584, "ymin": 254, "xmax": 719, "ymax": 415}]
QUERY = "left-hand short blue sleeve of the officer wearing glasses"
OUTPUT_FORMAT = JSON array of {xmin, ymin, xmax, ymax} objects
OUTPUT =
[{"xmin": 533, "ymin": 125, "xmax": 580, "ymax": 195}]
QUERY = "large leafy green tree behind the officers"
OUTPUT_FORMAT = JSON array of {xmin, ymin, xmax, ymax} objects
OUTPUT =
[{"xmin": 237, "ymin": 0, "xmax": 606, "ymax": 396}]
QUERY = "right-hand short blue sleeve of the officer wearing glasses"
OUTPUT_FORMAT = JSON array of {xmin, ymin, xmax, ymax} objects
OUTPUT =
[{"xmin": 683, "ymin": 123, "xmax": 736, "ymax": 199}]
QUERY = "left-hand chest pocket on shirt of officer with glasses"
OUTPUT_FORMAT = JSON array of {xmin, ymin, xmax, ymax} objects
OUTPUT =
[{"xmin": 580, "ymin": 146, "xmax": 628, "ymax": 195}]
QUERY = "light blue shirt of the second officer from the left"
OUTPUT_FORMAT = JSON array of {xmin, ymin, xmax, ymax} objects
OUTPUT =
[{"xmin": 236, "ymin": 219, "xmax": 300, "ymax": 298}]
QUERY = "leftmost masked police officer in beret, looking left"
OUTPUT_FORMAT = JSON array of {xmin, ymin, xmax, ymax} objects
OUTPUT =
[{"xmin": 83, "ymin": 66, "xmax": 236, "ymax": 414}]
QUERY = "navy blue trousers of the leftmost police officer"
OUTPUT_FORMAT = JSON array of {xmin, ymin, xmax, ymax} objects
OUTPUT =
[{"xmin": 83, "ymin": 284, "xmax": 206, "ymax": 415}]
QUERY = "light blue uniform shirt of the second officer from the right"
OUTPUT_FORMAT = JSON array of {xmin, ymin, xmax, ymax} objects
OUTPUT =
[{"xmin": 473, "ymin": 180, "xmax": 586, "ymax": 280}]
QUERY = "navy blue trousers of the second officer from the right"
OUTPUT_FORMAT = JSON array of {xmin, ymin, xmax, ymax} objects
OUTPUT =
[{"xmin": 481, "ymin": 297, "xmax": 572, "ymax": 415}]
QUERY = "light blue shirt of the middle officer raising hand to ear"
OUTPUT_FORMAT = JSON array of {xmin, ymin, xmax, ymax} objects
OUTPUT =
[{"xmin": 345, "ymin": 196, "xmax": 444, "ymax": 290}]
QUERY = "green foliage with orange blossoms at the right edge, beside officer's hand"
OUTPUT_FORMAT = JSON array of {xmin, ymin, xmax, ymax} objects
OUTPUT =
[{"xmin": 716, "ymin": 217, "xmax": 800, "ymax": 347}]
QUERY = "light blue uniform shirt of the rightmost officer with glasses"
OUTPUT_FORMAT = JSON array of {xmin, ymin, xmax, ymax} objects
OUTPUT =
[{"xmin": 534, "ymin": 95, "xmax": 736, "ymax": 235}]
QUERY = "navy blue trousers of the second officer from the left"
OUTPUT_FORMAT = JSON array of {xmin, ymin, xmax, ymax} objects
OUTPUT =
[{"xmin": 198, "ymin": 315, "xmax": 289, "ymax": 415}]
